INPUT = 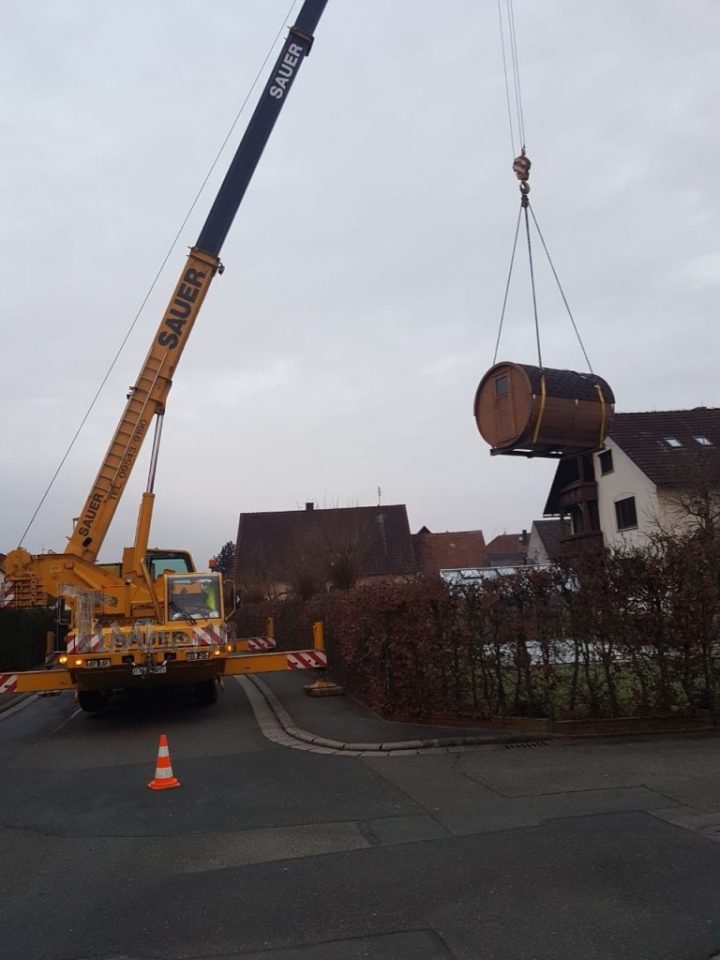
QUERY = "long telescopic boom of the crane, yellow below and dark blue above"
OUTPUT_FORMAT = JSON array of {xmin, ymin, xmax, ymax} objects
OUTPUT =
[{"xmin": 65, "ymin": 0, "xmax": 327, "ymax": 563}]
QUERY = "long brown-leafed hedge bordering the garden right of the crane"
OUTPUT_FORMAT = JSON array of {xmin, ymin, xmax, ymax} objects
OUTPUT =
[{"xmin": 239, "ymin": 538, "xmax": 720, "ymax": 719}]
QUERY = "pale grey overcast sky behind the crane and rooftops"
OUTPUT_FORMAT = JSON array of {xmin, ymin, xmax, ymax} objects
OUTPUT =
[{"xmin": 0, "ymin": 0, "xmax": 720, "ymax": 566}]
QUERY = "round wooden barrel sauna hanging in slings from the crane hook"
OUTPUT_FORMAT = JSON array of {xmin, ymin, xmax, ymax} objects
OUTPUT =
[{"xmin": 475, "ymin": 362, "xmax": 615, "ymax": 457}]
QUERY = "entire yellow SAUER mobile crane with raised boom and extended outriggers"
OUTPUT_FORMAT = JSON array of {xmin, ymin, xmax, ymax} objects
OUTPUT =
[{"xmin": 0, "ymin": 0, "xmax": 327, "ymax": 712}]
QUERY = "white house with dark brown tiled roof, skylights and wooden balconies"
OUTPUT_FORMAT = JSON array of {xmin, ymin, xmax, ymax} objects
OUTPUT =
[{"xmin": 545, "ymin": 407, "xmax": 720, "ymax": 549}]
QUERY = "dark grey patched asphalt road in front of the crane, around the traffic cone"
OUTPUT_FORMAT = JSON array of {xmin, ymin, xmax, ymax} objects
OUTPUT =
[{"xmin": 0, "ymin": 678, "xmax": 720, "ymax": 960}]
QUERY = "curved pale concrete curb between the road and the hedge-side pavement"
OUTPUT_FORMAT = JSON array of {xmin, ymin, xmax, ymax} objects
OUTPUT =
[{"xmin": 244, "ymin": 674, "xmax": 553, "ymax": 756}]
